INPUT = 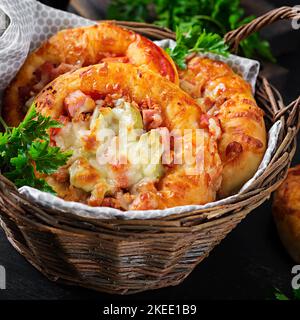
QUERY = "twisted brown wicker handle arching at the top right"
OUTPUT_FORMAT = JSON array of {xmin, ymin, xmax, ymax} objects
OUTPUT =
[{"xmin": 224, "ymin": 6, "xmax": 300, "ymax": 53}]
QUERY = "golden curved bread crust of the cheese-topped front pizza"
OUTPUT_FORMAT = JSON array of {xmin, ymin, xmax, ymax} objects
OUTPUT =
[{"xmin": 35, "ymin": 63, "xmax": 222, "ymax": 210}]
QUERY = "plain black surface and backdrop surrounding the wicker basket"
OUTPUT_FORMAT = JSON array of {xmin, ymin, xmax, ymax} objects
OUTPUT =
[{"xmin": 0, "ymin": 0, "xmax": 300, "ymax": 301}]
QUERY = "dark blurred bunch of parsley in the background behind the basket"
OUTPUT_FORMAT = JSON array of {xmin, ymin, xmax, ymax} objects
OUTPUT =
[{"xmin": 107, "ymin": 0, "xmax": 275, "ymax": 62}]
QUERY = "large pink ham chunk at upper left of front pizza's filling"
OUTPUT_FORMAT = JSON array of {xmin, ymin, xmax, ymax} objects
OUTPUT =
[{"xmin": 64, "ymin": 90, "xmax": 96, "ymax": 118}]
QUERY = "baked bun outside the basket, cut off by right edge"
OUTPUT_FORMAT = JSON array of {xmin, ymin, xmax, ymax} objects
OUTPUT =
[{"xmin": 273, "ymin": 165, "xmax": 300, "ymax": 263}]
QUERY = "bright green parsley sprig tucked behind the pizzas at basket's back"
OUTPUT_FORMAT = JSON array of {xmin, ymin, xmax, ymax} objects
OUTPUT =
[{"xmin": 167, "ymin": 23, "xmax": 229, "ymax": 69}]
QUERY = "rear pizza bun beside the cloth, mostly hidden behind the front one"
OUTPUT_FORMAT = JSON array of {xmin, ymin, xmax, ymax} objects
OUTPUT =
[{"xmin": 2, "ymin": 23, "xmax": 178, "ymax": 126}]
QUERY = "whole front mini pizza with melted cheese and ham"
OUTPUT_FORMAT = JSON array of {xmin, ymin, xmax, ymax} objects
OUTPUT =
[{"xmin": 34, "ymin": 62, "xmax": 222, "ymax": 210}]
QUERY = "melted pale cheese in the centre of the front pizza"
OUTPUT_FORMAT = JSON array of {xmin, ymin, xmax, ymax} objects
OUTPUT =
[{"xmin": 54, "ymin": 99, "xmax": 163, "ymax": 200}]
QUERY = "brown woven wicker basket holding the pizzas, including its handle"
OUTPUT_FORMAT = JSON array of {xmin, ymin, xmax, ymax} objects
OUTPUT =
[{"xmin": 0, "ymin": 7, "xmax": 300, "ymax": 294}]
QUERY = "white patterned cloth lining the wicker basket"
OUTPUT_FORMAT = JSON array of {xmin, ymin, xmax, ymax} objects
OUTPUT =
[{"xmin": 0, "ymin": 0, "xmax": 282, "ymax": 219}]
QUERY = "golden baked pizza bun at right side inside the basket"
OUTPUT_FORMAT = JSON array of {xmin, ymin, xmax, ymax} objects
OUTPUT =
[{"xmin": 179, "ymin": 57, "xmax": 266, "ymax": 197}]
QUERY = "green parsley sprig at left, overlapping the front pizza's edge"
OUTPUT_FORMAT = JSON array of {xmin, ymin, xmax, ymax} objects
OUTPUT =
[{"xmin": 0, "ymin": 105, "xmax": 72, "ymax": 193}]
